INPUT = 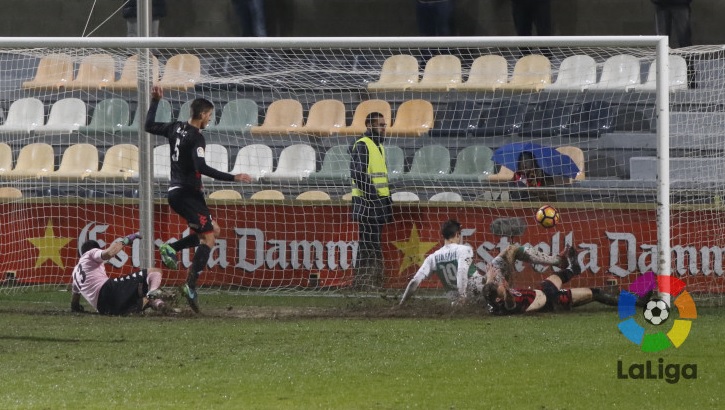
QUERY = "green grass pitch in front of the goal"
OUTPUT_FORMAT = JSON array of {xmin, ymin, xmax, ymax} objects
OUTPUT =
[{"xmin": 0, "ymin": 291, "xmax": 725, "ymax": 409}]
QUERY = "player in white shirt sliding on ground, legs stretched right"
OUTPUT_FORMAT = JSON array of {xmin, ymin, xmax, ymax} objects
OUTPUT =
[{"xmin": 400, "ymin": 219, "xmax": 576, "ymax": 305}]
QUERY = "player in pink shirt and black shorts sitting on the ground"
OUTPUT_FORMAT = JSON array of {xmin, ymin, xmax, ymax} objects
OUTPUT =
[{"xmin": 71, "ymin": 233, "xmax": 165, "ymax": 315}]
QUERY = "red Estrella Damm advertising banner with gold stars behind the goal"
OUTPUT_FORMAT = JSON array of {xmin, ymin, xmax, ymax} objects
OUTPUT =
[{"xmin": 0, "ymin": 203, "xmax": 725, "ymax": 293}]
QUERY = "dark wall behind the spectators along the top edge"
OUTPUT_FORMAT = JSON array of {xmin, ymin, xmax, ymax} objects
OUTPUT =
[{"xmin": 0, "ymin": 0, "xmax": 725, "ymax": 44}]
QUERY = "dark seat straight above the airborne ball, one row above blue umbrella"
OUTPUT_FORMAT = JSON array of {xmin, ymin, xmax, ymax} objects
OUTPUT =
[{"xmin": 521, "ymin": 100, "xmax": 574, "ymax": 137}]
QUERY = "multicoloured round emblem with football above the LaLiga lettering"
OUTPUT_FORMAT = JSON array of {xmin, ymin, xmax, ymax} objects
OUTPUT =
[{"xmin": 618, "ymin": 272, "xmax": 697, "ymax": 352}]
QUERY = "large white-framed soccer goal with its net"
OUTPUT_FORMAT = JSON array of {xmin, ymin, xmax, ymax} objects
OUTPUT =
[{"xmin": 0, "ymin": 37, "xmax": 725, "ymax": 302}]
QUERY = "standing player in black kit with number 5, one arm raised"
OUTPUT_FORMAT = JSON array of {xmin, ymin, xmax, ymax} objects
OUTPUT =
[{"xmin": 145, "ymin": 86, "xmax": 252, "ymax": 312}]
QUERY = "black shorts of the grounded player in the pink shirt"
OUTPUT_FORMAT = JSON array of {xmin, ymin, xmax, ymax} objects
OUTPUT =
[{"xmin": 97, "ymin": 269, "xmax": 149, "ymax": 315}]
